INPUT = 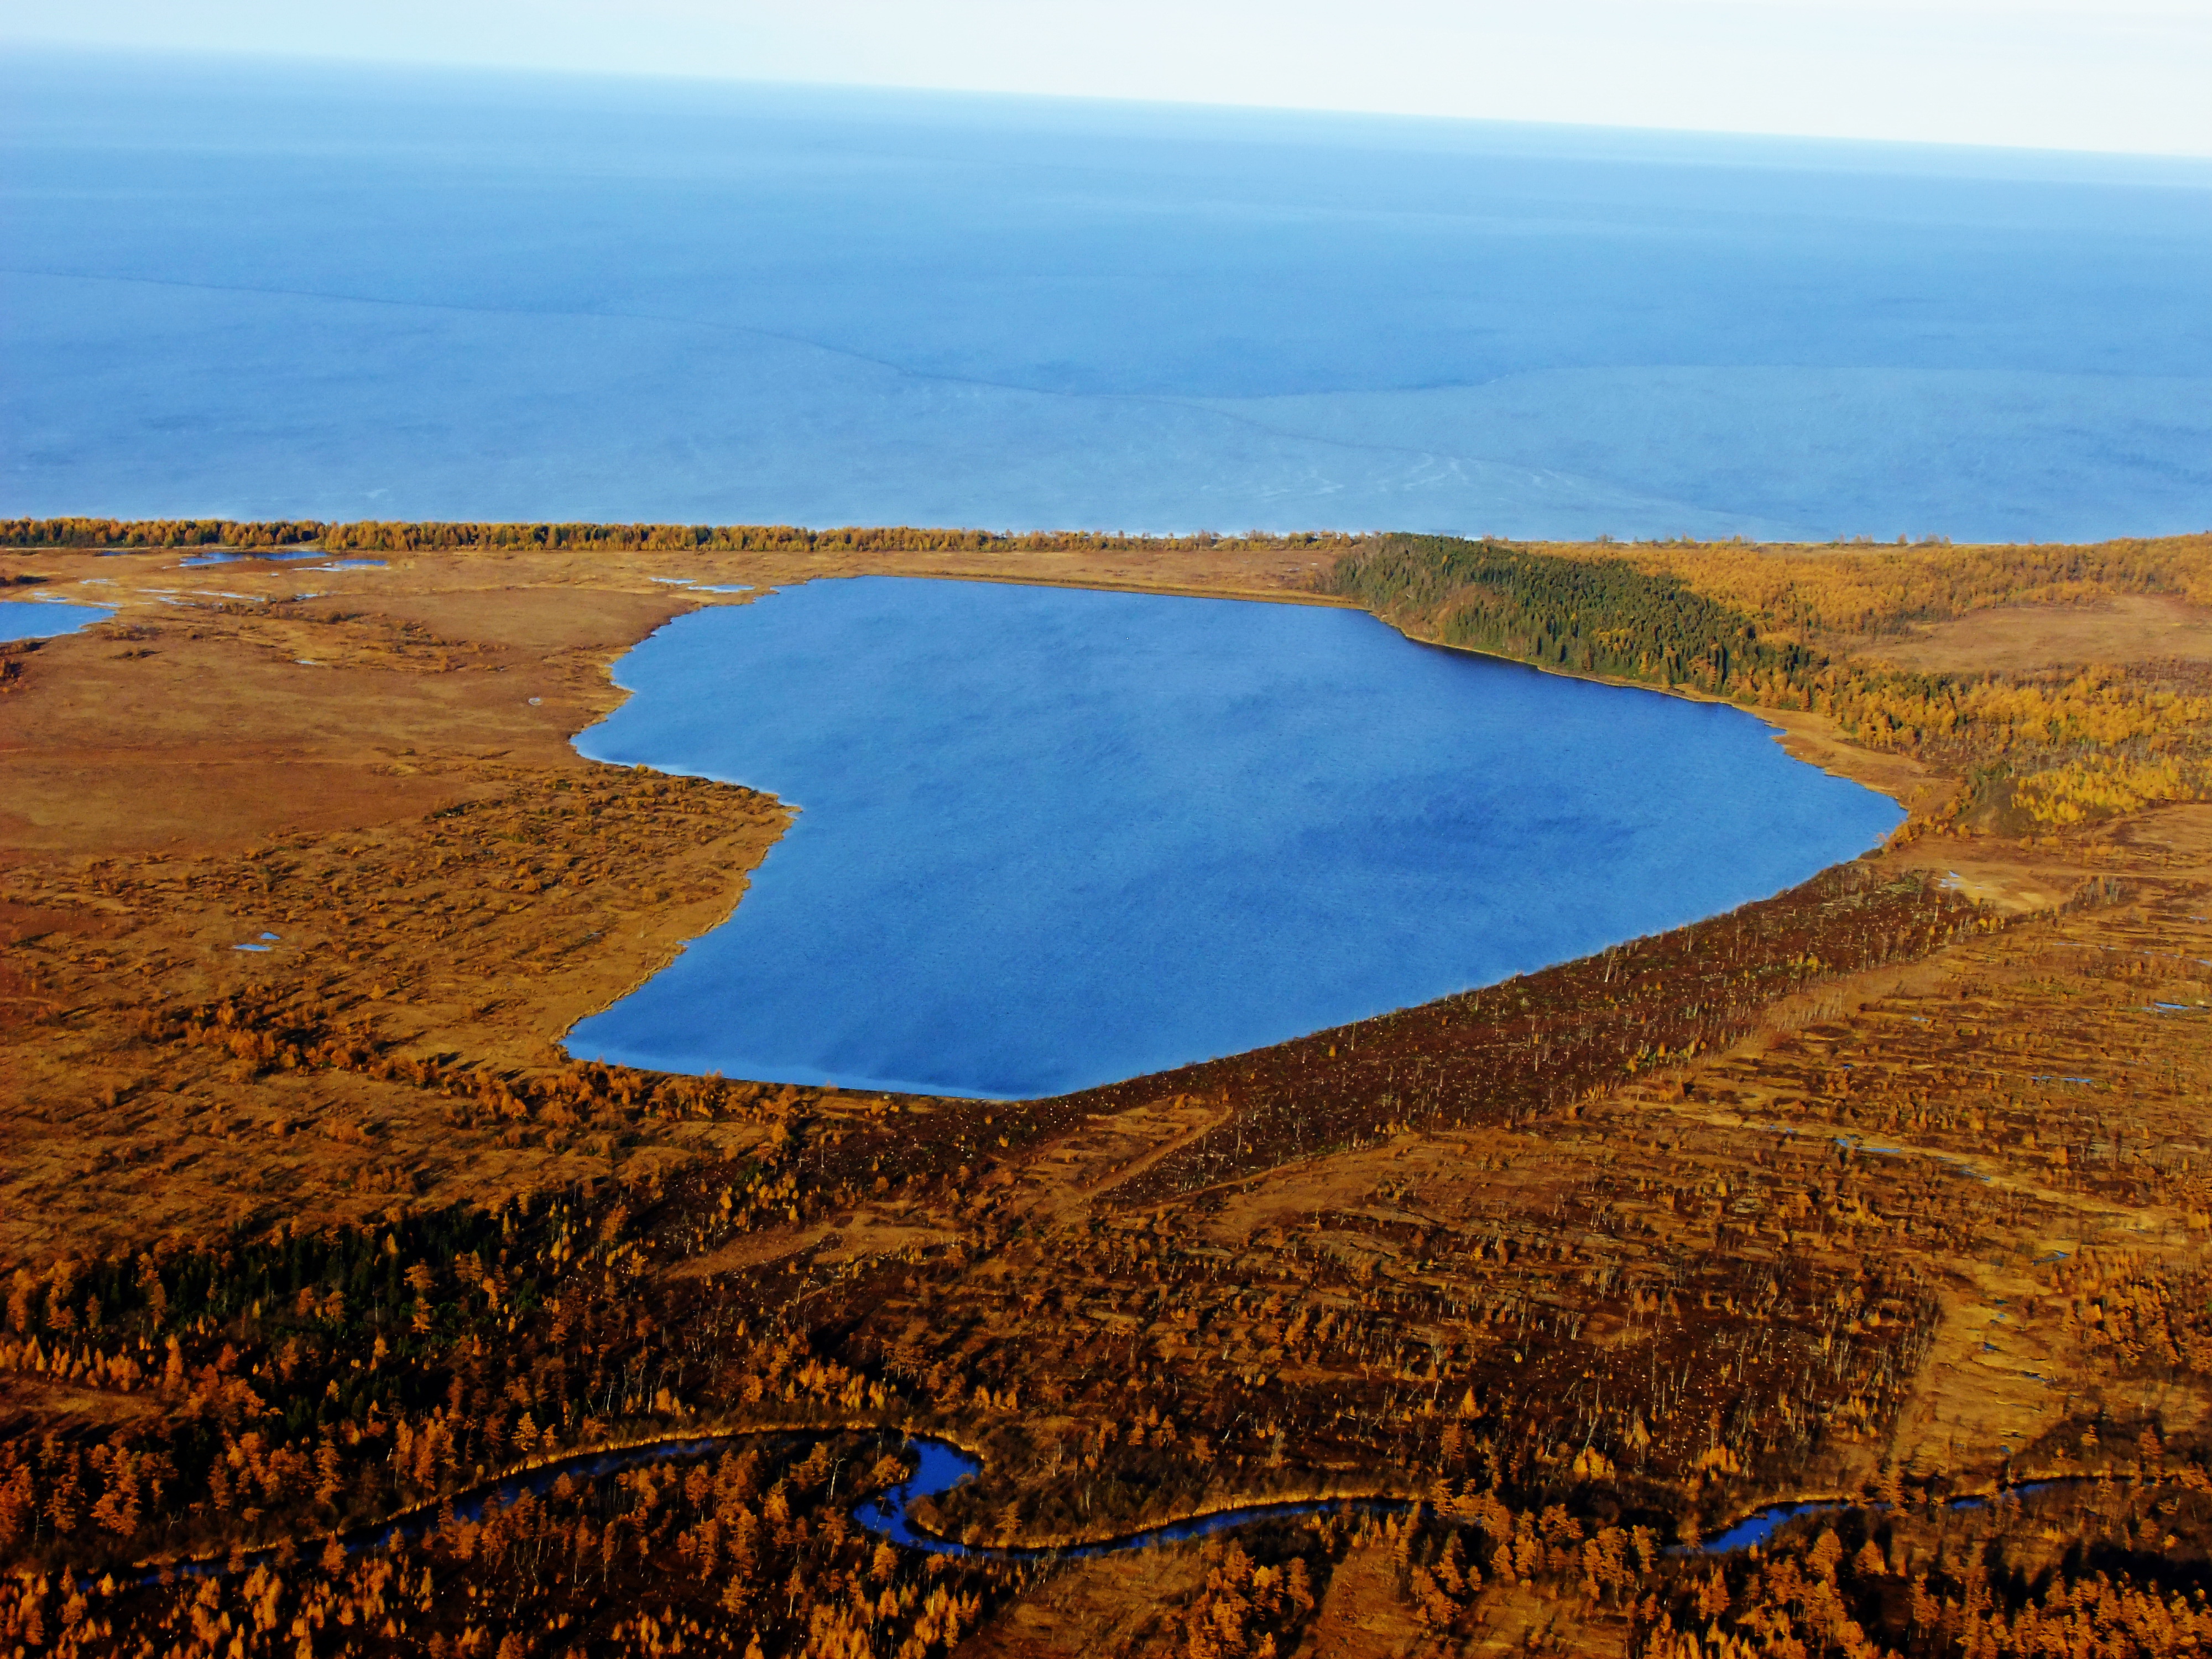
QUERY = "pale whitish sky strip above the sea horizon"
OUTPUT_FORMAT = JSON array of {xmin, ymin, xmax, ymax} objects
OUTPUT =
[{"xmin": 0, "ymin": 0, "xmax": 2212, "ymax": 155}]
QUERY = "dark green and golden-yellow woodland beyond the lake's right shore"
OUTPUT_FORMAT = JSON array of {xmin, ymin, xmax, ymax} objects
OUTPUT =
[{"xmin": 1323, "ymin": 535, "xmax": 2212, "ymax": 834}]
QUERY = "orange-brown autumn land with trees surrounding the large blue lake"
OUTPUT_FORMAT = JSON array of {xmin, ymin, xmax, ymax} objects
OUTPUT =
[{"xmin": 0, "ymin": 520, "xmax": 2212, "ymax": 1659}]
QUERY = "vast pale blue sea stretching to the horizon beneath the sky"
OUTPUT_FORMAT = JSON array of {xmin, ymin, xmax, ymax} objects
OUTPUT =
[{"xmin": 0, "ymin": 49, "xmax": 2212, "ymax": 540}]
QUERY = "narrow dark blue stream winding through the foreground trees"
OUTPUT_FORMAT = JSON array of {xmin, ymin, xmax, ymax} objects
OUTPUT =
[{"xmin": 137, "ymin": 1429, "xmax": 2062, "ymax": 1584}]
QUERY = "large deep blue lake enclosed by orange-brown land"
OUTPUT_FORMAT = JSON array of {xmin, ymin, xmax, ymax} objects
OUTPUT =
[{"xmin": 568, "ymin": 577, "xmax": 1902, "ymax": 1097}]
